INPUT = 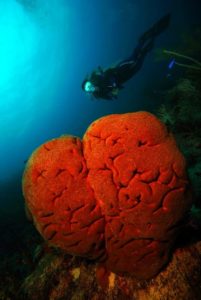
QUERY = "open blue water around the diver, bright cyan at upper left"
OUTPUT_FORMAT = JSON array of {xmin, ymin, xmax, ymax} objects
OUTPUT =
[{"xmin": 0, "ymin": 0, "xmax": 201, "ymax": 215}]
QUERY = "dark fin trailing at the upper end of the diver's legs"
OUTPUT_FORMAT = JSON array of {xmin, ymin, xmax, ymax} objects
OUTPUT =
[{"xmin": 139, "ymin": 13, "xmax": 170, "ymax": 43}]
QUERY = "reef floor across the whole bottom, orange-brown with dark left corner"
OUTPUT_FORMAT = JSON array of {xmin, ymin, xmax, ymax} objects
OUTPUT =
[{"xmin": 0, "ymin": 218, "xmax": 201, "ymax": 300}]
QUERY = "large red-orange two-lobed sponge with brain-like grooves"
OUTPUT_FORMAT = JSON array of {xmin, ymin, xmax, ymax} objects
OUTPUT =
[{"xmin": 23, "ymin": 112, "xmax": 191, "ymax": 279}]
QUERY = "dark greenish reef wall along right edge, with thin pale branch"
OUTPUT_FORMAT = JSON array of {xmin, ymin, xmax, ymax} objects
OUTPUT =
[{"xmin": 156, "ymin": 25, "xmax": 201, "ymax": 209}]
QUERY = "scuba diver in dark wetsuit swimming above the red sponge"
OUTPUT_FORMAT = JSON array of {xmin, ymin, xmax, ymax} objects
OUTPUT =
[{"xmin": 82, "ymin": 14, "xmax": 170, "ymax": 100}]
